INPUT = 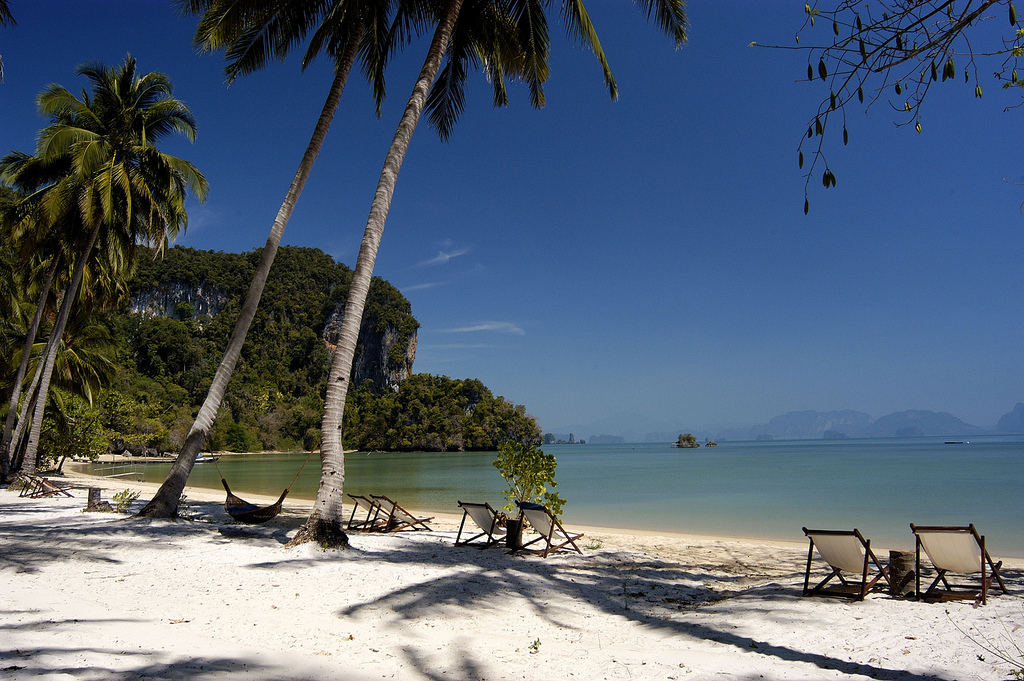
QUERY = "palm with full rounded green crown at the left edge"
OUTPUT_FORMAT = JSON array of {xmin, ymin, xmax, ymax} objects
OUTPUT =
[{"xmin": 0, "ymin": 55, "xmax": 207, "ymax": 475}]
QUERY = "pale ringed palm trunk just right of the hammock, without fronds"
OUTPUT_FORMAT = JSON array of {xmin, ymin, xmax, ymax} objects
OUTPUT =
[{"xmin": 289, "ymin": 0, "xmax": 463, "ymax": 548}]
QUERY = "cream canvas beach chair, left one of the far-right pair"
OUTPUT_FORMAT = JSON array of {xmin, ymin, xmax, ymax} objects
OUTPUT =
[{"xmin": 804, "ymin": 527, "xmax": 889, "ymax": 600}]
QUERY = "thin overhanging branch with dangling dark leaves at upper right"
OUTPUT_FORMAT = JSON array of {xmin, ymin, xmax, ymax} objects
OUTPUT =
[{"xmin": 766, "ymin": 0, "xmax": 1024, "ymax": 214}]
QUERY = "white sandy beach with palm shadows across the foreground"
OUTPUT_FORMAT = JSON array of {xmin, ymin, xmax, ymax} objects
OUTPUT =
[{"xmin": 0, "ymin": 478, "xmax": 1024, "ymax": 681}]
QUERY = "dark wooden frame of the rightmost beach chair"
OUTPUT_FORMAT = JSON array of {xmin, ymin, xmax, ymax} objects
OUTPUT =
[{"xmin": 910, "ymin": 522, "xmax": 1010, "ymax": 605}]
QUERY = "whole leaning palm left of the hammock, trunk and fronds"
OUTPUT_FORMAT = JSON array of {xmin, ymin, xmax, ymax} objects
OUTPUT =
[{"xmin": 139, "ymin": 0, "xmax": 395, "ymax": 518}]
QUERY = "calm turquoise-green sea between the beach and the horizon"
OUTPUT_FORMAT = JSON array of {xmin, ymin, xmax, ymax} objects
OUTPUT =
[{"xmin": 90, "ymin": 435, "xmax": 1024, "ymax": 557}]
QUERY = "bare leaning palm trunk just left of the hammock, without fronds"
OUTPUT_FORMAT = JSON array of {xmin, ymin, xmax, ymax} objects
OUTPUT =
[{"xmin": 138, "ymin": 31, "xmax": 362, "ymax": 518}]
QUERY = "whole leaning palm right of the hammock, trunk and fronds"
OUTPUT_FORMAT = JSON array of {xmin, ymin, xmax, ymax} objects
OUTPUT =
[{"xmin": 292, "ymin": 0, "xmax": 686, "ymax": 546}]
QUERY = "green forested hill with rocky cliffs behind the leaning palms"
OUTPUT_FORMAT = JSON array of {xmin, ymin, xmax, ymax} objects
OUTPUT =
[{"xmin": 102, "ymin": 247, "xmax": 537, "ymax": 451}]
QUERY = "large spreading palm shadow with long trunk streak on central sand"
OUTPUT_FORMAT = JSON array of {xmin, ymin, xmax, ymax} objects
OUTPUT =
[{"xmin": 338, "ymin": 542, "xmax": 1024, "ymax": 681}]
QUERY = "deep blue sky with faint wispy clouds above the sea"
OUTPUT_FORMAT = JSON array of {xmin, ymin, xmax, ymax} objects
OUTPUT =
[{"xmin": 0, "ymin": 0, "xmax": 1024, "ymax": 436}]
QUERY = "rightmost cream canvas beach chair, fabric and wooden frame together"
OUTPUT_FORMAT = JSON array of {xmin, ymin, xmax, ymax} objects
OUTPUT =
[{"xmin": 910, "ymin": 522, "xmax": 1009, "ymax": 604}]
